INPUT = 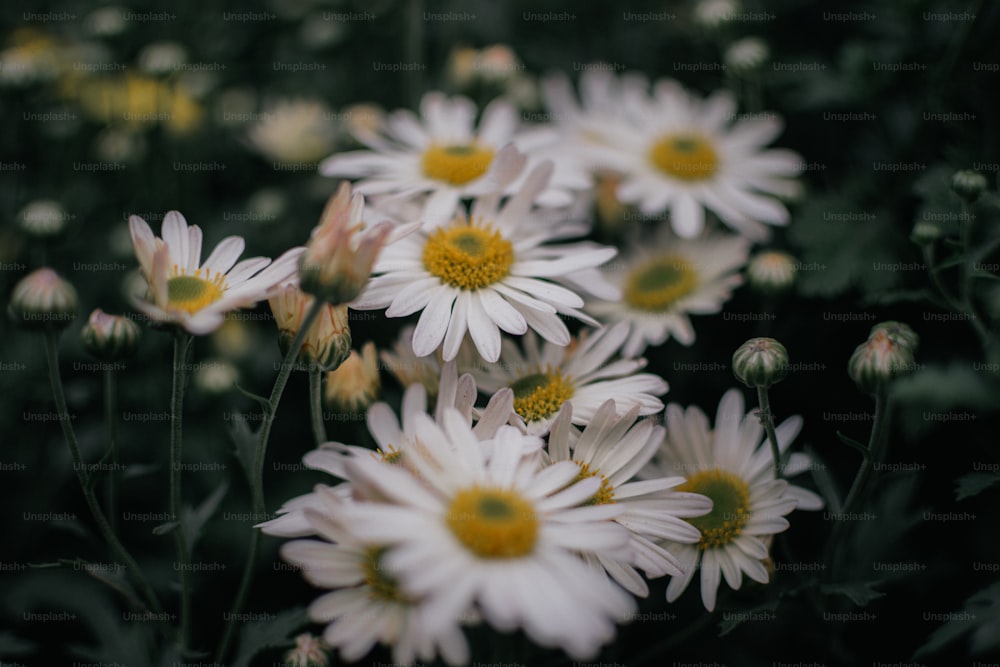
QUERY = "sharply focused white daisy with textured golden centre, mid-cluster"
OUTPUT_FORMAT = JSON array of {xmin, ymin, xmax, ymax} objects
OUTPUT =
[{"xmin": 351, "ymin": 149, "xmax": 617, "ymax": 362}]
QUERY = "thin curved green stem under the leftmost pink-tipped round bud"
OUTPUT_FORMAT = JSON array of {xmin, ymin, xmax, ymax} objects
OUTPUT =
[{"xmin": 45, "ymin": 330, "xmax": 175, "ymax": 641}]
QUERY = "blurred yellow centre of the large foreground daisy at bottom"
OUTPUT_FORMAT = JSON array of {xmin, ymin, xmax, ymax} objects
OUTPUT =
[{"xmin": 445, "ymin": 486, "xmax": 538, "ymax": 558}]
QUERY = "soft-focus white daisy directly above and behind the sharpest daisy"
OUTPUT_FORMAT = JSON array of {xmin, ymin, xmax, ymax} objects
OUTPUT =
[{"xmin": 320, "ymin": 92, "xmax": 590, "ymax": 226}]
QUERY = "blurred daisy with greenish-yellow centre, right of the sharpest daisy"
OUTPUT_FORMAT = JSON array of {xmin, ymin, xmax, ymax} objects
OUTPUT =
[{"xmin": 587, "ymin": 229, "xmax": 750, "ymax": 356}]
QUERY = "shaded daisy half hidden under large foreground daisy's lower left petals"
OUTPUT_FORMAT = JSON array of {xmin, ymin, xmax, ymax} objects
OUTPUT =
[{"xmin": 281, "ymin": 487, "xmax": 469, "ymax": 665}]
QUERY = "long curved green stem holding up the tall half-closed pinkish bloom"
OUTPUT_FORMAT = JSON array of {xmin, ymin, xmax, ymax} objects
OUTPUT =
[{"xmin": 215, "ymin": 299, "xmax": 326, "ymax": 663}]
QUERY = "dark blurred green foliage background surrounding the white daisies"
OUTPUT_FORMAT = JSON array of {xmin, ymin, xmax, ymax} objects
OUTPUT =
[{"xmin": 0, "ymin": 0, "xmax": 1000, "ymax": 667}]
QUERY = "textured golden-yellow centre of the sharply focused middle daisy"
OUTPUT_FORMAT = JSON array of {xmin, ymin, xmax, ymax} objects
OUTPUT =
[{"xmin": 423, "ymin": 224, "xmax": 514, "ymax": 290}]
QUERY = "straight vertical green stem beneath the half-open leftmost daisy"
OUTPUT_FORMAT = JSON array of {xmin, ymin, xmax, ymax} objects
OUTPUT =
[{"xmin": 170, "ymin": 329, "xmax": 191, "ymax": 649}]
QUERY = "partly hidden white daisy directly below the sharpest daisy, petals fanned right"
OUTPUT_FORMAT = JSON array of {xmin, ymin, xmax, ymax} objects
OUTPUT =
[{"xmin": 470, "ymin": 323, "xmax": 669, "ymax": 435}]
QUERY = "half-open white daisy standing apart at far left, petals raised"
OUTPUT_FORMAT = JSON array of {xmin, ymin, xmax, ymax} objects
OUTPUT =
[{"xmin": 129, "ymin": 211, "xmax": 303, "ymax": 335}]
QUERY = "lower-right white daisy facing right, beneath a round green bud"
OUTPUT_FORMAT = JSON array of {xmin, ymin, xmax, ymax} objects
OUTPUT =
[{"xmin": 646, "ymin": 389, "xmax": 823, "ymax": 611}]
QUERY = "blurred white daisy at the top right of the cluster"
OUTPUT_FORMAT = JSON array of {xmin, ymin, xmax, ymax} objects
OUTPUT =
[{"xmin": 588, "ymin": 80, "xmax": 802, "ymax": 239}]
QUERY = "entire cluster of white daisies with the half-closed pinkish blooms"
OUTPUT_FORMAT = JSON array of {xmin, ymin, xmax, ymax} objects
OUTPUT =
[{"xmin": 111, "ymin": 60, "xmax": 822, "ymax": 664}]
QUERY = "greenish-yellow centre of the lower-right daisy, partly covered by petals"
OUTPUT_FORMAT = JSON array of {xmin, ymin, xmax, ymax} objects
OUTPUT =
[{"xmin": 677, "ymin": 468, "xmax": 750, "ymax": 550}]
